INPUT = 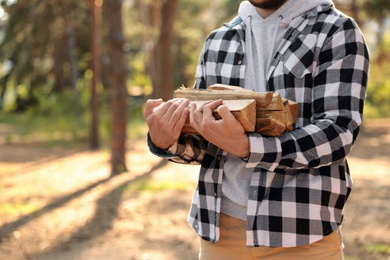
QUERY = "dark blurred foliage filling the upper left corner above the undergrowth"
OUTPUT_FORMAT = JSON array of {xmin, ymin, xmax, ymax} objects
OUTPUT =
[{"xmin": 0, "ymin": 0, "xmax": 90, "ymax": 106}]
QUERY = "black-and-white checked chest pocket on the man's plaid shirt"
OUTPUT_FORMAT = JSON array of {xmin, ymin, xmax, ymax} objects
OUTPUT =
[{"xmin": 283, "ymin": 34, "xmax": 317, "ymax": 79}]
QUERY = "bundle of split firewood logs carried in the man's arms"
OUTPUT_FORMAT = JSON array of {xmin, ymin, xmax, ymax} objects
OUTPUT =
[{"xmin": 174, "ymin": 84, "xmax": 298, "ymax": 136}]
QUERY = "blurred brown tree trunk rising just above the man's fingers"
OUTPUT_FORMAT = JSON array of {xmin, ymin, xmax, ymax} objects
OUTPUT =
[{"xmin": 148, "ymin": 0, "xmax": 178, "ymax": 100}]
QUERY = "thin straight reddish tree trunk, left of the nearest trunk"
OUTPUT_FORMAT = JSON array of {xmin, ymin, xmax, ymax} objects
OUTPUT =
[{"xmin": 89, "ymin": 0, "xmax": 102, "ymax": 149}]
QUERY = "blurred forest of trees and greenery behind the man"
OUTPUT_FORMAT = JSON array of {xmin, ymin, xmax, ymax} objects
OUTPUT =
[{"xmin": 0, "ymin": 0, "xmax": 390, "ymax": 255}]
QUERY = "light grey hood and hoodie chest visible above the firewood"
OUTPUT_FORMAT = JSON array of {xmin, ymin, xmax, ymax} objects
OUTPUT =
[{"xmin": 238, "ymin": 0, "xmax": 333, "ymax": 92}]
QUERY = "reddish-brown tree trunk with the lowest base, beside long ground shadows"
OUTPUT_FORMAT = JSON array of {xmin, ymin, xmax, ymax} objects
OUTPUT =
[{"xmin": 104, "ymin": 0, "xmax": 127, "ymax": 175}]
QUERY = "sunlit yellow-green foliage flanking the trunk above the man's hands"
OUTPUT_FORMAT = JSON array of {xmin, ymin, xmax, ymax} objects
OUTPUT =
[{"xmin": 124, "ymin": 0, "xmax": 240, "ymax": 91}]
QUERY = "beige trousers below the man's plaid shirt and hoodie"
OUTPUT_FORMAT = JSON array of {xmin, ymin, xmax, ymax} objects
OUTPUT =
[{"xmin": 199, "ymin": 214, "xmax": 344, "ymax": 260}]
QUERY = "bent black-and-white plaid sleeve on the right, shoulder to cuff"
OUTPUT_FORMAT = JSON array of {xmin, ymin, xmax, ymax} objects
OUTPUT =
[{"xmin": 246, "ymin": 18, "xmax": 369, "ymax": 171}]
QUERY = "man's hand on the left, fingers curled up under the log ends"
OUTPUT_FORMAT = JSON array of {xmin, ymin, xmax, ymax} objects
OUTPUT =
[{"xmin": 144, "ymin": 99, "xmax": 190, "ymax": 149}]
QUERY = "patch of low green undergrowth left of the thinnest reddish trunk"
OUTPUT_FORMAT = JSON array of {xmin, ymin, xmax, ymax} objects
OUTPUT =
[{"xmin": 1, "ymin": 91, "xmax": 88, "ymax": 146}]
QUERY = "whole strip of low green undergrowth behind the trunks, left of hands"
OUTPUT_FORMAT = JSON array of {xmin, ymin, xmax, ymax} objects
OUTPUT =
[{"xmin": 0, "ymin": 90, "xmax": 146, "ymax": 147}]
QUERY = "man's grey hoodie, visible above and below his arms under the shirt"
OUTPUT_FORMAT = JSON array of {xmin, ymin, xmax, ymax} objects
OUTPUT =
[{"xmin": 221, "ymin": 0, "xmax": 333, "ymax": 220}]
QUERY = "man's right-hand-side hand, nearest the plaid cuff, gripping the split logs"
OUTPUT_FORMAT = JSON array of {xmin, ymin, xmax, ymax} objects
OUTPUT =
[{"xmin": 190, "ymin": 100, "xmax": 249, "ymax": 157}]
